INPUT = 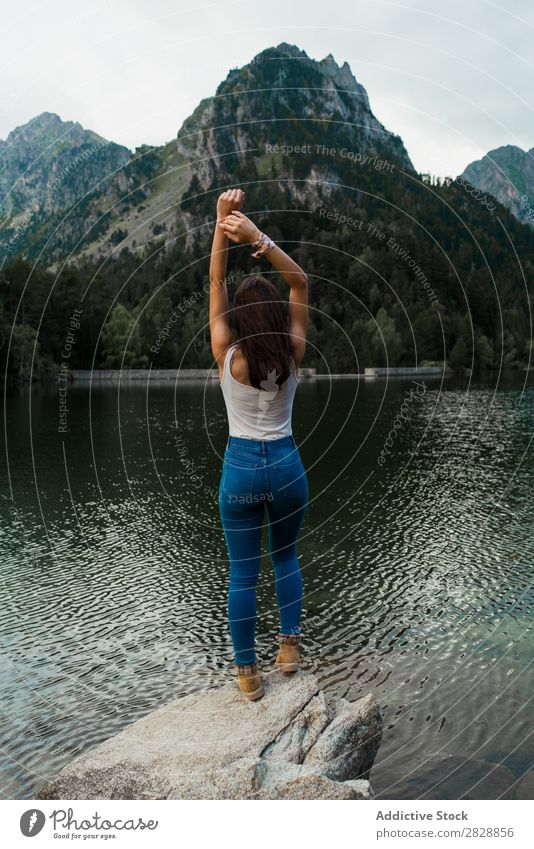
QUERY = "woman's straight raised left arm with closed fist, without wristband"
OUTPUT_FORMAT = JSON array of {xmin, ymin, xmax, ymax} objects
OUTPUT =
[{"xmin": 210, "ymin": 189, "xmax": 245, "ymax": 369}]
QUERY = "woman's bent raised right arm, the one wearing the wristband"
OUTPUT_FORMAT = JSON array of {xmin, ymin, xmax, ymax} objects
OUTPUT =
[{"xmin": 218, "ymin": 209, "xmax": 308, "ymax": 365}]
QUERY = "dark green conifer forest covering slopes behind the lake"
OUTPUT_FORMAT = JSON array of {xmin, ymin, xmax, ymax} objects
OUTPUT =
[{"xmin": 0, "ymin": 168, "xmax": 534, "ymax": 382}]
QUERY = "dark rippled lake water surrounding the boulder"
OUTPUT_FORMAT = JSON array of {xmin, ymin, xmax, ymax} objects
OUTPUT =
[{"xmin": 0, "ymin": 375, "xmax": 534, "ymax": 798}]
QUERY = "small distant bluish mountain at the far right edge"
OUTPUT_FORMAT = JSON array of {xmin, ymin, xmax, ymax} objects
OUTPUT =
[{"xmin": 461, "ymin": 144, "xmax": 534, "ymax": 226}]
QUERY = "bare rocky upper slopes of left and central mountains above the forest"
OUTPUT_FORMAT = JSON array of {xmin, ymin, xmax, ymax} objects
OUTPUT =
[{"xmin": 0, "ymin": 43, "xmax": 414, "ymax": 263}]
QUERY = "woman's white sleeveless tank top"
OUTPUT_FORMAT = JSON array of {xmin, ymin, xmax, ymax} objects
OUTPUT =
[{"xmin": 221, "ymin": 345, "xmax": 299, "ymax": 440}]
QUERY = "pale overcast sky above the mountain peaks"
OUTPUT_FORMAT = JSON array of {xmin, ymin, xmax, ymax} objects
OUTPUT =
[{"xmin": 0, "ymin": 0, "xmax": 534, "ymax": 176}]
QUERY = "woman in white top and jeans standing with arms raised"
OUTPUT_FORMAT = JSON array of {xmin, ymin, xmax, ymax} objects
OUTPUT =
[{"xmin": 210, "ymin": 189, "xmax": 308, "ymax": 699}]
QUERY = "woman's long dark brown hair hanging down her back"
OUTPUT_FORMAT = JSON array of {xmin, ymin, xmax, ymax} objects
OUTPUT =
[{"xmin": 234, "ymin": 274, "xmax": 296, "ymax": 389}]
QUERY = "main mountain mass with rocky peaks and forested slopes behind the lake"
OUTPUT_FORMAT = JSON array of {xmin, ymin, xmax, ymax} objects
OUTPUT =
[{"xmin": 0, "ymin": 43, "xmax": 534, "ymax": 379}]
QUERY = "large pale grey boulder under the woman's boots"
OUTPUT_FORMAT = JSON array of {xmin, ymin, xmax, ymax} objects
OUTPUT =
[{"xmin": 37, "ymin": 671, "xmax": 382, "ymax": 799}]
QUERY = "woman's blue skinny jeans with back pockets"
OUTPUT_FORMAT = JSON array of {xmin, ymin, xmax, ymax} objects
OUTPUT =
[{"xmin": 219, "ymin": 436, "xmax": 308, "ymax": 664}]
